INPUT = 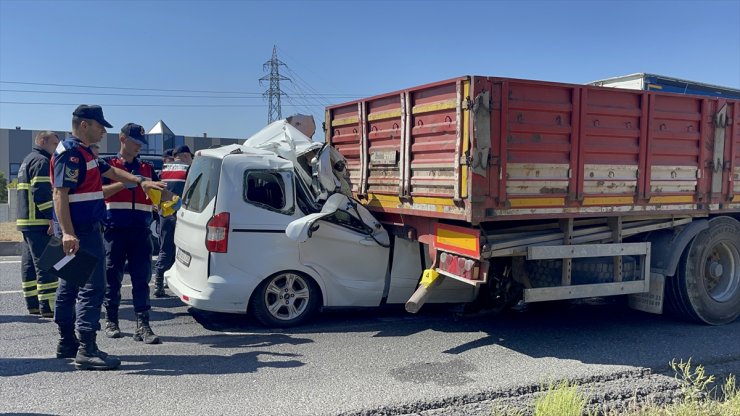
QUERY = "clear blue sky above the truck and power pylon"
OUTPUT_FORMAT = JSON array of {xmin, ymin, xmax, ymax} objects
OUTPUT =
[{"xmin": 0, "ymin": 0, "xmax": 740, "ymax": 138}]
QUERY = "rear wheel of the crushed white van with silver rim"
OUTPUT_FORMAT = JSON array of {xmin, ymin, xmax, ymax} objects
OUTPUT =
[{"xmin": 249, "ymin": 272, "xmax": 321, "ymax": 328}]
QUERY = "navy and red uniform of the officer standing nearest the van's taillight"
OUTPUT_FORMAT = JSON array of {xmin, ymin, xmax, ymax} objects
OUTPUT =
[{"xmin": 103, "ymin": 155, "xmax": 159, "ymax": 338}]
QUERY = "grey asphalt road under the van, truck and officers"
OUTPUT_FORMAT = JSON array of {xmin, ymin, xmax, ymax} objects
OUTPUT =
[{"xmin": 0, "ymin": 257, "xmax": 740, "ymax": 415}]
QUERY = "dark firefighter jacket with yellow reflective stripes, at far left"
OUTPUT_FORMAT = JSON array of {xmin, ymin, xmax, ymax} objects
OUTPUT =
[{"xmin": 15, "ymin": 146, "xmax": 54, "ymax": 231}]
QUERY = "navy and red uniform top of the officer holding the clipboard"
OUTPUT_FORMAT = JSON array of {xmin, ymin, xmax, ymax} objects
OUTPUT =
[{"xmin": 51, "ymin": 137, "xmax": 110, "ymax": 231}]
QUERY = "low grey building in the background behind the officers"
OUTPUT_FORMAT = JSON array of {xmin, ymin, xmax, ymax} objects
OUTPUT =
[{"xmin": 0, "ymin": 120, "xmax": 244, "ymax": 181}]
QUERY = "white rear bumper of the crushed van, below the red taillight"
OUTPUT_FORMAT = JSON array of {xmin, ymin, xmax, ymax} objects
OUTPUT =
[{"xmin": 164, "ymin": 267, "xmax": 249, "ymax": 314}]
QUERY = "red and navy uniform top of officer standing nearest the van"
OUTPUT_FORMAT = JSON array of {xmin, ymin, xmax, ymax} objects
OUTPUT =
[{"xmin": 103, "ymin": 155, "xmax": 157, "ymax": 228}]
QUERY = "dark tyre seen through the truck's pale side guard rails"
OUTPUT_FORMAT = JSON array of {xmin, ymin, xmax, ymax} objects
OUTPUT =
[{"xmin": 526, "ymin": 256, "xmax": 641, "ymax": 287}]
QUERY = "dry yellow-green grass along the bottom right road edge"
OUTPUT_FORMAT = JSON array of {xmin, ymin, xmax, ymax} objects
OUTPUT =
[{"xmin": 491, "ymin": 359, "xmax": 740, "ymax": 416}]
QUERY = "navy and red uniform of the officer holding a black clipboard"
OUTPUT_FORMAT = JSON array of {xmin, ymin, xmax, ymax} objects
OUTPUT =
[{"xmin": 51, "ymin": 137, "xmax": 110, "ymax": 334}]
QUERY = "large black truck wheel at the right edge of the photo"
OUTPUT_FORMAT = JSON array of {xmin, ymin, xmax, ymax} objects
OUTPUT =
[{"xmin": 666, "ymin": 217, "xmax": 740, "ymax": 325}]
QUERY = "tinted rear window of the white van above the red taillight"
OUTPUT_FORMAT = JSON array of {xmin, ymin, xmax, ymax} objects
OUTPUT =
[{"xmin": 182, "ymin": 156, "xmax": 221, "ymax": 212}]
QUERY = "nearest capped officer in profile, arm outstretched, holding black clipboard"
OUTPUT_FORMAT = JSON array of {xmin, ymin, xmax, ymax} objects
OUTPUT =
[{"xmin": 50, "ymin": 105, "xmax": 162, "ymax": 370}]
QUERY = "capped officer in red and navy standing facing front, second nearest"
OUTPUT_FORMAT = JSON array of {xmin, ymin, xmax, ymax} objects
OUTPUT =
[{"xmin": 103, "ymin": 123, "xmax": 161, "ymax": 344}]
